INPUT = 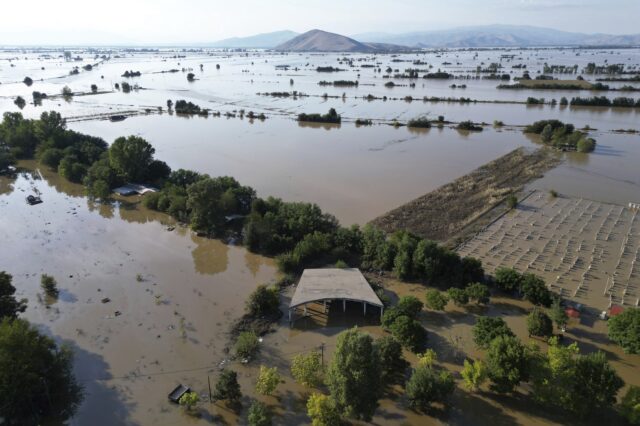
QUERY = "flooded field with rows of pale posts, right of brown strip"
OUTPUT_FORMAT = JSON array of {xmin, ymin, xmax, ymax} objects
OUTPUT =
[{"xmin": 459, "ymin": 191, "xmax": 640, "ymax": 310}]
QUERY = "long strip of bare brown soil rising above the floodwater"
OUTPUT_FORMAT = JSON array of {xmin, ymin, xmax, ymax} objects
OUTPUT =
[{"xmin": 371, "ymin": 148, "xmax": 560, "ymax": 246}]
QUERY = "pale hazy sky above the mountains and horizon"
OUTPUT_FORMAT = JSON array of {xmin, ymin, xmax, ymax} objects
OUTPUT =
[{"xmin": 0, "ymin": 0, "xmax": 640, "ymax": 45}]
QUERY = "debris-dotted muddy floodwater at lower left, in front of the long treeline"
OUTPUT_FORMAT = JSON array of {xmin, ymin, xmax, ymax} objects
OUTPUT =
[{"xmin": 0, "ymin": 163, "xmax": 276, "ymax": 425}]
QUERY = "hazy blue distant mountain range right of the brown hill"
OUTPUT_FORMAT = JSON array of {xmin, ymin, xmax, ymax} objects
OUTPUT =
[{"xmin": 354, "ymin": 25, "xmax": 640, "ymax": 47}]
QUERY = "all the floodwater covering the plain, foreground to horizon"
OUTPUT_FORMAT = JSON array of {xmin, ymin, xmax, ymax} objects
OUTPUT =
[{"xmin": 0, "ymin": 45, "xmax": 640, "ymax": 425}]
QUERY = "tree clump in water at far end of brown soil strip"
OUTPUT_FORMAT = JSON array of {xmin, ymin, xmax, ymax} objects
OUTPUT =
[{"xmin": 524, "ymin": 120, "xmax": 596, "ymax": 152}]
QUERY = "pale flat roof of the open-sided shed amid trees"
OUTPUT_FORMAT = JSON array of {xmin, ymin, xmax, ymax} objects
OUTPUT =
[{"xmin": 289, "ymin": 268, "xmax": 382, "ymax": 308}]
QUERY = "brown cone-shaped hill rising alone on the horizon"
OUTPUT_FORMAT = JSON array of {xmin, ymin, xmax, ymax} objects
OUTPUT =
[{"xmin": 275, "ymin": 30, "xmax": 410, "ymax": 53}]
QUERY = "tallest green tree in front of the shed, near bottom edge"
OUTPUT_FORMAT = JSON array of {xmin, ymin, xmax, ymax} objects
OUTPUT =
[{"xmin": 327, "ymin": 328, "xmax": 382, "ymax": 421}]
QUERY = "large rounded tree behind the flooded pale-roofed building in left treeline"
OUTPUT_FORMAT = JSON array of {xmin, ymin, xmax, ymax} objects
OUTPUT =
[{"xmin": 109, "ymin": 136, "xmax": 156, "ymax": 182}]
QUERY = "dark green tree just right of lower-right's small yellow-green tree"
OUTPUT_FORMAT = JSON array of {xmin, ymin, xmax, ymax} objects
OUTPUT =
[{"xmin": 486, "ymin": 335, "xmax": 530, "ymax": 393}]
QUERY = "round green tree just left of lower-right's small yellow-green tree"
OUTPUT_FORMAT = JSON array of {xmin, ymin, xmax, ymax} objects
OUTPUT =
[{"xmin": 405, "ymin": 366, "xmax": 455, "ymax": 411}]
